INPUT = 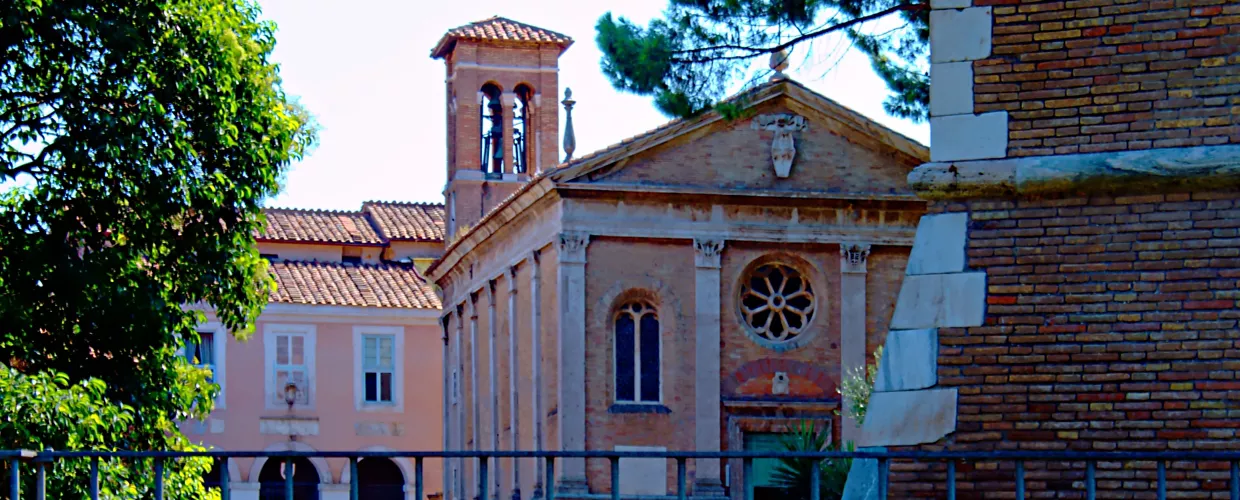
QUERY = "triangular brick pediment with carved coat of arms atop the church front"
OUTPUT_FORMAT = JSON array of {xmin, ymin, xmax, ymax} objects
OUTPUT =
[{"xmin": 554, "ymin": 81, "xmax": 929, "ymax": 197}]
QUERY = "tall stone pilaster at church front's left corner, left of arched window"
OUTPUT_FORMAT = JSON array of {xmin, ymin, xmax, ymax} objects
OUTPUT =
[{"xmin": 557, "ymin": 231, "xmax": 590, "ymax": 494}]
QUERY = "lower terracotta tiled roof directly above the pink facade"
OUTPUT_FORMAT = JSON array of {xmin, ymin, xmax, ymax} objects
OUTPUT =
[{"xmin": 269, "ymin": 261, "xmax": 440, "ymax": 309}]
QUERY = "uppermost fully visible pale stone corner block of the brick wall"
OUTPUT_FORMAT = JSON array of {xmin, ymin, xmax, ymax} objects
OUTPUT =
[{"xmin": 930, "ymin": 7, "xmax": 993, "ymax": 63}]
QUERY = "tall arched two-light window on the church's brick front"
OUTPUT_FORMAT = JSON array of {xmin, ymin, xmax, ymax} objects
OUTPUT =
[{"xmin": 615, "ymin": 301, "xmax": 662, "ymax": 403}]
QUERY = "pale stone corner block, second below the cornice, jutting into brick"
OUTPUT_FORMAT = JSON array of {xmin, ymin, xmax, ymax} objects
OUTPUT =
[{"xmin": 890, "ymin": 273, "xmax": 986, "ymax": 330}]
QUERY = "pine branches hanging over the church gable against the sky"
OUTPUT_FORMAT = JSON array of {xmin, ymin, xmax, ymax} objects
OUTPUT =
[{"xmin": 596, "ymin": 0, "xmax": 930, "ymax": 120}]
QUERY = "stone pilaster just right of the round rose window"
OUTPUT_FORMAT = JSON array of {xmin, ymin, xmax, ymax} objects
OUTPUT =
[{"xmin": 839, "ymin": 243, "xmax": 869, "ymax": 443}]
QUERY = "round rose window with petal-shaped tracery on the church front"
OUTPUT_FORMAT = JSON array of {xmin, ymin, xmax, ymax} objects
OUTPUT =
[{"xmin": 740, "ymin": 263, "xmax": 816, "ymax": 342}]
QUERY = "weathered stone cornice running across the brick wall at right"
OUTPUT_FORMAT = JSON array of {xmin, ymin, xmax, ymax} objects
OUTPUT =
[{"xmin": 909, "ymin": 145, "xmax": 1240, "ymax": 200}]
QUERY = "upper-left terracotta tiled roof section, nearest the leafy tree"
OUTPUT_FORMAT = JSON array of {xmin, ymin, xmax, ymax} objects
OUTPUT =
[{"xmin": 255, "ymin": 208, "xmax": 383, "ymax": 244}]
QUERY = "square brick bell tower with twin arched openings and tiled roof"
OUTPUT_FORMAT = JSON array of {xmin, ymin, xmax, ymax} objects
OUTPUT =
[{"xmin": 430, "ymin": 16, "xmax": 573, "ymax": 242}]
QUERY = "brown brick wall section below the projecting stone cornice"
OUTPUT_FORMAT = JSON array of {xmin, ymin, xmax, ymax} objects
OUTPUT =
[{"xmin": 893, "ymin": 192, "xmax": 1240, "ymax": 498}]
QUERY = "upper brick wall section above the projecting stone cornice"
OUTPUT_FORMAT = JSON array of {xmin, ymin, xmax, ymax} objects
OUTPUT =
[{"xmin": 973, "ymin": 0, "xmax": 1240, "ymax": 156}]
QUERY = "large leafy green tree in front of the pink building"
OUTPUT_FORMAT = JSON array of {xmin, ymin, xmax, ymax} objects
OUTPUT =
[{"xmin": 0, "ymin": 0, "xmax": 315, "ymax": 498}]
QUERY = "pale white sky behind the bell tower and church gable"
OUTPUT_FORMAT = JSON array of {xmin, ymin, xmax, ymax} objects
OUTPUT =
[{"xmin": 259, "ymin": 0, "xmax": 929, "ymax": 210}]
